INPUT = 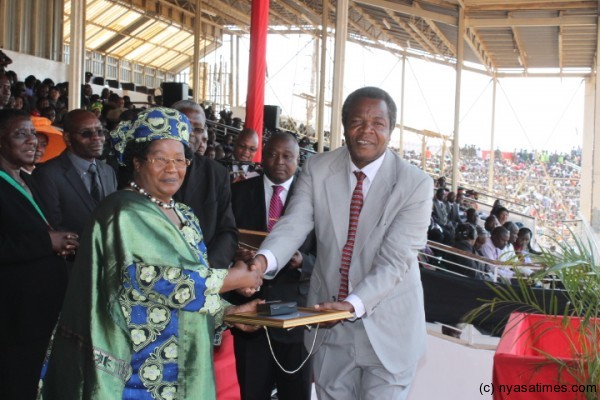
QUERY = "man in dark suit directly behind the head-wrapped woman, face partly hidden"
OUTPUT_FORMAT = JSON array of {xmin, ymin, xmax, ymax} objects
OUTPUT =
[{"xmin": 172, "ymin": 100, "xmax": 238, "ymax": 268}]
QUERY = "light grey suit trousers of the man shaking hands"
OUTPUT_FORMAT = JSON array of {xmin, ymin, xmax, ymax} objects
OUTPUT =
[{"xmin": 313, "ymin": 319, "xmax": 416, "ymax": 400}]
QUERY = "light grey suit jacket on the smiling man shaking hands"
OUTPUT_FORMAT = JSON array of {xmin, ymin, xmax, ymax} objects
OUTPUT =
[{"xmin": 261, "ymin": 147, "xmax": 433, "ymax": 374}]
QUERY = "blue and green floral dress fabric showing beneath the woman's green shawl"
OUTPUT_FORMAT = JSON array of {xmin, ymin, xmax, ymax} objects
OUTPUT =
[{"xmin": 119, "ymin": 206, "xmax": 226, "ymax": 400}]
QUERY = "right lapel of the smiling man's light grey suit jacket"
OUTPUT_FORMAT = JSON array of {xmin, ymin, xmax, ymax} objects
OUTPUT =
[{"xmin": 352, "ymin": 151, "xmax": 396, "ymax": 259}]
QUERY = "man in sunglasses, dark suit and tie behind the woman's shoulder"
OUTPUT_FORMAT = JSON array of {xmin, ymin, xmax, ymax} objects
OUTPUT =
[{"xmin": 33, "ymin": 110, "xmax": 117, "ymax": 235}]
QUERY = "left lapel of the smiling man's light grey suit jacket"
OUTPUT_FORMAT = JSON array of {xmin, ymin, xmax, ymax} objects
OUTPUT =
[{"xmin": 324, "ymin": 151, "xmax": 352, "ymax": 251}]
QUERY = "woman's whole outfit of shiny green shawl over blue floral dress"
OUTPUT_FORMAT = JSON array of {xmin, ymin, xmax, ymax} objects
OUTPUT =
[{"xmin": 39, "ymin": 191, "xmax": 228, "ymax": 400}]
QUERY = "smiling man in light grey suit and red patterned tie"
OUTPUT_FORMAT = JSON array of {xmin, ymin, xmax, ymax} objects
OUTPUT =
[{"xmin": 250, "ymin": 87, "xmax": 433, "ymax": 400}]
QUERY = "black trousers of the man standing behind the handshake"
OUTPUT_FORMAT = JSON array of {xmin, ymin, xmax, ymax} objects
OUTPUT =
[{"xmin": 234, "ymin": 329, "xmax": 311, "ymax": 400}]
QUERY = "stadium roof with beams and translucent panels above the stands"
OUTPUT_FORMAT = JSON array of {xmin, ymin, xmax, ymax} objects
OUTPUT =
[{"xmin": 64, "ymin": 0, "xmax": 600, "ymax": 76}]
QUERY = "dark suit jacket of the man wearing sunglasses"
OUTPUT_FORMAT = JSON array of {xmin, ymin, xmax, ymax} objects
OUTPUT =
[{"xmin": 33, "ymin": 150, "xmax": 117, "ymax": 235}]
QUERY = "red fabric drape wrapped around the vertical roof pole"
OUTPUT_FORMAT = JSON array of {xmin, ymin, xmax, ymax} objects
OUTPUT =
[{"xmin": 244, "ymin": 0, "xmax": 269, "ymax": 162}]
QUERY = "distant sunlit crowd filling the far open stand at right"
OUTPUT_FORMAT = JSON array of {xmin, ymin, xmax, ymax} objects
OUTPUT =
[{"xmin": 405, "ymin": 146, "xmax": 581, "ymax": 244}]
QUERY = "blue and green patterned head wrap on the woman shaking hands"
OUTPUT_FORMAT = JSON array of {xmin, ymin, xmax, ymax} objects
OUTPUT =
[{"xmin": 110, "ymin": 107, "xmax": 192, "ymax": 165}]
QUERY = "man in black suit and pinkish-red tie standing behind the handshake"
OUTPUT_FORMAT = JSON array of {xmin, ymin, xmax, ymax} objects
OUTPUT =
[{"xmin": 231, "ymin": 133, "xmax": 315, "ymax": 400}]
